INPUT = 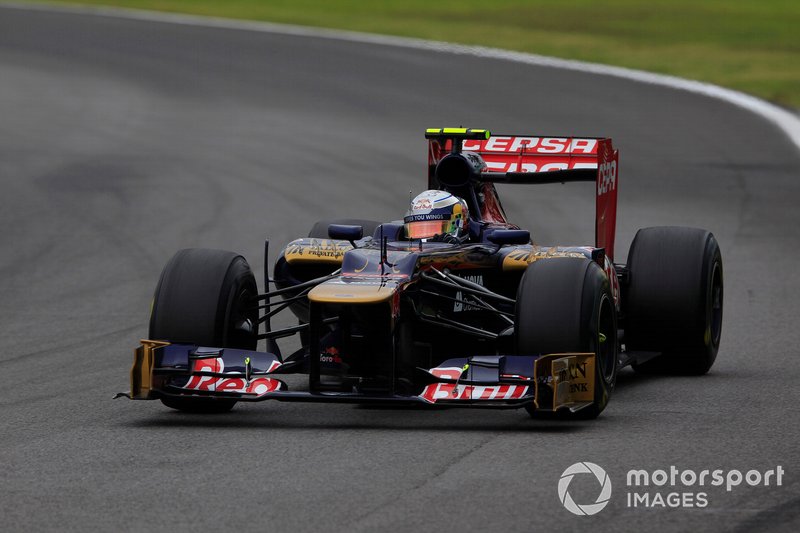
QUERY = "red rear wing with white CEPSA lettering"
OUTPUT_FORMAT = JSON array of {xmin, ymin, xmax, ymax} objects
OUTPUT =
[{"xmin": 426, "ymin": 128, "xmax": 619, "ymax": 261}]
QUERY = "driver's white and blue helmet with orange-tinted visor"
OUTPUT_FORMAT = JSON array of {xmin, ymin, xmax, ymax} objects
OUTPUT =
[{"xmin": 403, "ymin": 190, "xmax": 469, "ymax": 239}]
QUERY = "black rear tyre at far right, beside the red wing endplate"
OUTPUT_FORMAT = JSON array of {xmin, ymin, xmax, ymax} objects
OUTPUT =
[{"xmin": 625, "ymin": 227, "xmax": 723, "ymax": 375}]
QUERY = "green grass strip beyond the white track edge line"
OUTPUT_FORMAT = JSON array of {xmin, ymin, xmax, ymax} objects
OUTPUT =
[{"xmin": 17, "ymin": 0, "xmax": 800, "ymax": 108}]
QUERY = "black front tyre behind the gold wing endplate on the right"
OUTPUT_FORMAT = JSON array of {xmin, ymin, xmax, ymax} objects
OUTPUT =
[{"xmin": 515, "ymin": 258, "xmax": 619, "ymax": 419}]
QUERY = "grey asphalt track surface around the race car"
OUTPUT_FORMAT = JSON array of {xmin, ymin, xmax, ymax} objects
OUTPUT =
[{"xmin": 0, "ymin": 5, "xmax": 800, "ymax": 532}]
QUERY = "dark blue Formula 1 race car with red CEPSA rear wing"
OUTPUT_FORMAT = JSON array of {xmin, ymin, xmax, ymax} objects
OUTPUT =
[{"xmin": 124, "ymin": 128, "xmax": 723, "ymax": 419}]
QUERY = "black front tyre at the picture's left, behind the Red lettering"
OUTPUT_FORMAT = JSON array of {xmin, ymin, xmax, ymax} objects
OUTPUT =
[{"xmin": 149, "ymin": 248, "xmax": 258, "ymax": 413}]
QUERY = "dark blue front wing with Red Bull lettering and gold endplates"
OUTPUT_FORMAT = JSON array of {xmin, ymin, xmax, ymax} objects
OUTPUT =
[{"xmin": 117, "ymin": 340, "xmax": 595, "ymax": 412}]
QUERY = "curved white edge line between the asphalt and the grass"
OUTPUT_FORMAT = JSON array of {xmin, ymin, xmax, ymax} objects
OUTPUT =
[{"xmin": 6, "ymin": 2, "xmax": 800, "ymax": 150}]
